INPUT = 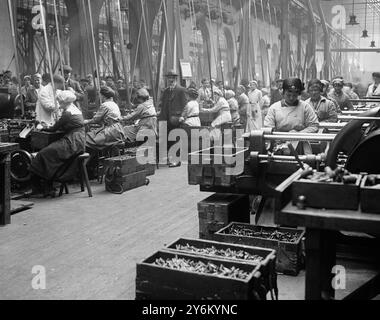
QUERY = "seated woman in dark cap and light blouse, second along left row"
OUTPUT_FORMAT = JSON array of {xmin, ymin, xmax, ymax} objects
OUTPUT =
[{"xmin": 84, "ymin": 87, "xmax": 126, "ymax": 151}]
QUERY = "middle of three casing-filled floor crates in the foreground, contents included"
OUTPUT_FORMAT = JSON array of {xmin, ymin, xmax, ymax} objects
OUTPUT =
[{"xmin": 165, "ymin": 238, "xmax": 278, "ymax": 300}]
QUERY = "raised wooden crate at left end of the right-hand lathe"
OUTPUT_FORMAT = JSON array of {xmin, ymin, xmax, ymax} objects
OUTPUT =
[{"xmin": 188, "ymin": 147, "xmax": 249, "ymax": 187}]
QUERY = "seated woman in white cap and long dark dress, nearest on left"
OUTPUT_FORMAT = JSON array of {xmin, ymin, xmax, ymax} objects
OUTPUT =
[{"xmin": 30, "ymin": 90, "xmax": 86, "ymax": 197}]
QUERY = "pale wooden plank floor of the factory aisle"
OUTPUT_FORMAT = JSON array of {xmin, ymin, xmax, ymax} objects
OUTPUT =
[{"xmin": 0, "ymin": 166, "xmax": 374, "ymax": 300}]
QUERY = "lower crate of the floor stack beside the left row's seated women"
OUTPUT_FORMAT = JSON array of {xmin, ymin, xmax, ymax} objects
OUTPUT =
[{"xmin": 105, "ymin": 170, "xmax": 147, "ymax": 193}]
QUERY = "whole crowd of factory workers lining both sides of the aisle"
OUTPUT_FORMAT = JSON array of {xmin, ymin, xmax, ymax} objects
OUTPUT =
[{"xmin": 3, "ymin": 62, "xmax": 380, "ymax": 195}]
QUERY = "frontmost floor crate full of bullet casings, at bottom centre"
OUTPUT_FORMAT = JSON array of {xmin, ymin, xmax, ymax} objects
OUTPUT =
[{"xmin": 136, "ymin": 251, "xmax": 267, "ymax": 300}]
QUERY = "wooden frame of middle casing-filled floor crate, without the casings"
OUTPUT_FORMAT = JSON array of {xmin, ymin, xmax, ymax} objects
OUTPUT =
[{"xmin": 166, "ymin": 238, "xmax": 278, "ymax": 298}]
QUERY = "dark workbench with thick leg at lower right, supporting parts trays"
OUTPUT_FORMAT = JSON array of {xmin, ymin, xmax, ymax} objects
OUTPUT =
[{"xmin": 275, "ymin": 204, "xmax": 380, "ymax": 300}]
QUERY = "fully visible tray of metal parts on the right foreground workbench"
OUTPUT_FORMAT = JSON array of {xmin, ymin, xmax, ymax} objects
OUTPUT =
[{"xmin": 292, "ymin": 166, "xmax": 362, "ymax": 210}]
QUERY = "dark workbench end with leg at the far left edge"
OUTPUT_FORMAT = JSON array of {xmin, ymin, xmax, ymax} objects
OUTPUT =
[{"xmin": 0, "ymin": 143, "xmax": 19, "ymax": 226}]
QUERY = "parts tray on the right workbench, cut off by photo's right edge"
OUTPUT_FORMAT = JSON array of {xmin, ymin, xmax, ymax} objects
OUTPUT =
[{"xmin": 360, "ymin": 174, "xmax": 380, "ymax": 213}]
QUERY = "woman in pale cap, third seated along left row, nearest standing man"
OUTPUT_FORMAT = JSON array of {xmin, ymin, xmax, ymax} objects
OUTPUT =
[{"xmin": 123, "ymin": 88, "xmax": 157, "ymax": 142}]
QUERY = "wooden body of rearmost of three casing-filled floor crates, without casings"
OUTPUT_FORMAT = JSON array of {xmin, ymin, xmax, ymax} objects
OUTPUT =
[{"xmin": 214, "ymin": 222, "xmax": 305, "ymax": 276}]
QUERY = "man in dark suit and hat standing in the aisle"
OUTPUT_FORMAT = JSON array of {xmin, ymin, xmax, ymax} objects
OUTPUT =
[{"xmin": 158, "ymin": 70, "xmax": 187, "ymax": 168}]
